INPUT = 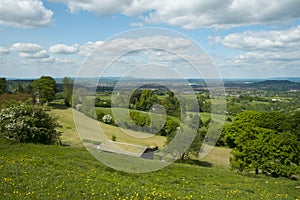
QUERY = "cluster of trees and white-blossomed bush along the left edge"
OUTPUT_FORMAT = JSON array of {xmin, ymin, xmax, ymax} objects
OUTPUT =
[{"xmin": 0, "ymin": 76, "xmax": 73, "ymax": 144}]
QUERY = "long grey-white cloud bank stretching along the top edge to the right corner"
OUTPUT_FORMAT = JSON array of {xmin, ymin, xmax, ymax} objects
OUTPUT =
[{"xmin": 52, "ymin": 0, "xmax": 300, "ymax": 29}]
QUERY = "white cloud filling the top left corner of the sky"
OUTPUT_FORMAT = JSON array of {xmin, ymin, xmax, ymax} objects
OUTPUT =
[{"xmin": 0, "ymin": 0, "xmax": 53, "ymax": 28}]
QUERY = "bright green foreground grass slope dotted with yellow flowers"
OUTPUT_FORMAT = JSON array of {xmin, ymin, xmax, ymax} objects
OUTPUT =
[{"xmin": 0, "ymin": 139, "xmax": 300, "ymax": 199}]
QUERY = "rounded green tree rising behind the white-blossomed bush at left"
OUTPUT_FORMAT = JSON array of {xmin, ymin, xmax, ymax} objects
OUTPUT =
[{"xmin": 32, "ymin": 76, "xmax": 57, "ymax": 104}]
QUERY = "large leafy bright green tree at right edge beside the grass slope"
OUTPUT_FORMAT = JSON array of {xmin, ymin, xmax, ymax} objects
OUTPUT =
[{"xmin": 225, "ymin": 111, "xmax": 300, "ymax": 177}]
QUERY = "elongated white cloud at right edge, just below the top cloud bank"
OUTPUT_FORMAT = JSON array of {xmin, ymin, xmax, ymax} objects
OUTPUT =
[{"xmin": 215, "ymin": 26, "xmax": 300, "ymax": 53}]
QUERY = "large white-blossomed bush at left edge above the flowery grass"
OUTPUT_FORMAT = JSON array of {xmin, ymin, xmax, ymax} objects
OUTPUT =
[{"xmin": 0, "ymin": 102, "xmax": 60, "ymax": 144}]
